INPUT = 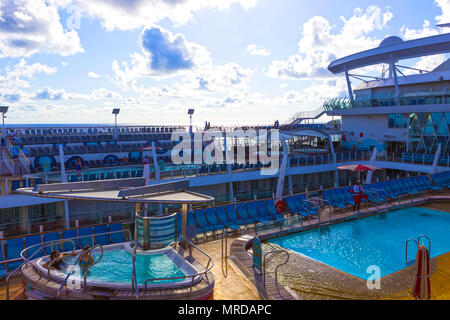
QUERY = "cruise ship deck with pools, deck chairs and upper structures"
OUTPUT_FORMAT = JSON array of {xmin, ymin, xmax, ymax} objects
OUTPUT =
[{"xmin": 0, "ymin": 28, "xmax": 450, "ymax": 300}]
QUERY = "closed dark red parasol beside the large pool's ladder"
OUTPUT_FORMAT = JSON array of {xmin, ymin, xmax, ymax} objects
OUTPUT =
[{"xmin": 412, "ymin": 245, "xmax": 430, "ymax": 300}]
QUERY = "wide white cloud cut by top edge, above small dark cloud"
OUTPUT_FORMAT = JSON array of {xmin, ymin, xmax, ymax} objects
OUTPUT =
[{"xmin": 74, "ymin": 0, "xmax": 257, "ymax": 30}]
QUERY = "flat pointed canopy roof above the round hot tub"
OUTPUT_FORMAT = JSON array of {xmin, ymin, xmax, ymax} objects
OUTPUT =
[{"xmin": 17, "ymin": 179, "xmax": 214, "ymax": 204}]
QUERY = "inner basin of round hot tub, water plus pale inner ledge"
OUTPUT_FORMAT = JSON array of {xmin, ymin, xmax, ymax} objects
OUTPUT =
[{"xmin": 37, "ymin": 244, "xmax": 201, "ymax": 288}]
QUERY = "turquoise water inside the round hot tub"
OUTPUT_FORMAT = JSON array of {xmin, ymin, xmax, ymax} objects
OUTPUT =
[{"xmin": 66, "ymin": 249, "xmax": 185, "ymax": 284}]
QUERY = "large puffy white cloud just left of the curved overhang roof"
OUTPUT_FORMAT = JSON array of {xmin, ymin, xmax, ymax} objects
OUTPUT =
[{"xmin": 267, "ymin": 6, "xmax": 393, "ymax": 79}]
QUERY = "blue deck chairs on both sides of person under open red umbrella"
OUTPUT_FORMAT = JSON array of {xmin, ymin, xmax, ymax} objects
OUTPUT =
[{"xmin": 322, "ymin": 176, "xmax": 442, "ymax": 209}]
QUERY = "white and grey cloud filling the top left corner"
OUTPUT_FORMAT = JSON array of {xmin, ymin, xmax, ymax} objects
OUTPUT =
[{"xmin": 0, "ymin": 0, "xmax": 83, "ymax": 58}]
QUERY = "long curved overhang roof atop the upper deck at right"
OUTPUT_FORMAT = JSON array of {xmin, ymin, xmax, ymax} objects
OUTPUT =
[{"xmin": 328, "ymin": 33, "xmax": 450, "ymax": 74}]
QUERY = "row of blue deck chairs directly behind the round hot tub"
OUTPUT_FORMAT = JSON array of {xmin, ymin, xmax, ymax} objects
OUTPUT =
[{"xmin": 0, "ymin": 223, "xmax": 130, "ymax": 278}]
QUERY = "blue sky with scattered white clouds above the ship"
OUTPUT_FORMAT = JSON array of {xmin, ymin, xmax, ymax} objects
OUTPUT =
[{"xmin": 0, "ymin": 0, "xmax": 450, "ymax": 125}]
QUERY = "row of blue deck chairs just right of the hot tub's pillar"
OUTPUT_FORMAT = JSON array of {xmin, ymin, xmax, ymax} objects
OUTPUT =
[{"xmin": 177, "ymin": 200, "xmax": 285, "ymax": 237}]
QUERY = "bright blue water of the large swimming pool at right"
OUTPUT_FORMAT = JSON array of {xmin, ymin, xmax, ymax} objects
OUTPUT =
[{"xmin": 270, "ymin": 207, "xmax": 450, "ymax": 279}]
